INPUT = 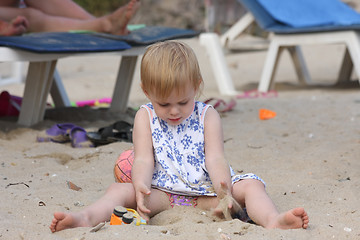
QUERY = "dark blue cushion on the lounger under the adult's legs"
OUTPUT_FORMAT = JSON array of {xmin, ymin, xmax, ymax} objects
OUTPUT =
[{"xmin": 0, "ymin": 26, "xmax": 199, "ymax": 53}]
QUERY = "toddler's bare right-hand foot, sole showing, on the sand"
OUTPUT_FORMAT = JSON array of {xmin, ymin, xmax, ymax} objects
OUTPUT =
[{"xmin": 268, "ymin": 208, "xmax": 309, "ymax": 229}]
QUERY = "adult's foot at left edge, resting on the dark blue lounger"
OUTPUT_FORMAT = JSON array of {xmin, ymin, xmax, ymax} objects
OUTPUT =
[{"xmin": 0, "ymin": 16, "xmax": 28, "ymax": 36}]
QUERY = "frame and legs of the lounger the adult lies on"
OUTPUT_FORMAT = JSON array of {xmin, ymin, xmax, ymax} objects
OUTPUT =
[{"xmin": 0, "ymin": 47, "xmax": 145, "ymax": 126}]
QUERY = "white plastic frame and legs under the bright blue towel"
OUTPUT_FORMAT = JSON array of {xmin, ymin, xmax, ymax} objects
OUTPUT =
[{"xmin": 258, "ymin": 31, "xmax": 360, "ymax": 92}]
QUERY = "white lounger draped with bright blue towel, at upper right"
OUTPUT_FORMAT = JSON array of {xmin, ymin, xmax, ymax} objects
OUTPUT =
[{"xmin": 238, "ymin": 0, "xmax": 360, "ymax": 92}]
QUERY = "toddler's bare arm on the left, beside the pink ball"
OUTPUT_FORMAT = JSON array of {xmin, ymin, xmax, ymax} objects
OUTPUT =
[{"xmin": 131, "ymin": 108, "xmax": 154, "ymax": 220}]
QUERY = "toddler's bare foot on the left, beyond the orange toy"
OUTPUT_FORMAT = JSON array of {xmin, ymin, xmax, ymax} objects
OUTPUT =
[{"xmin": 50, "ymin": 212, "xmax": 91, "ymax": 232}]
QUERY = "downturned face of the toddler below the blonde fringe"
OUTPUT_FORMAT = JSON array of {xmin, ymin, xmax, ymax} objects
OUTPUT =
[{"xmin": 148, "ymin": 84, "xmax": 196, "ymax": 125}]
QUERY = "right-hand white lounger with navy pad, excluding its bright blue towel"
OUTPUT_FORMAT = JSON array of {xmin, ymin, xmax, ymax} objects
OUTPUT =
[{"xmin": 226, "ymin": 0, "xmax": 360, "ymax": 92}]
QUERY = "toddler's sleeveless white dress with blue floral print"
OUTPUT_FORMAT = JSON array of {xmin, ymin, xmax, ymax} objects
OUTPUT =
[{"xmin": 141, "ymin": 102, "xmax": 262, "ymax": 196}]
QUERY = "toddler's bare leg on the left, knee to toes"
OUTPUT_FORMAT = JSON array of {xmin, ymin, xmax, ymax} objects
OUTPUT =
[{"xmin": 50, "ymin": 183, "xmax": 136, "ymax": 232}]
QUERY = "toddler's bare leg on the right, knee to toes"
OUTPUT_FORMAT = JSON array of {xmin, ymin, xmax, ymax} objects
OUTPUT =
[{"xmin": 233, "ymin": 179, "xmax": 309, "ymax": 229}]
